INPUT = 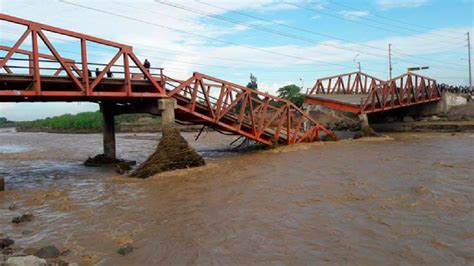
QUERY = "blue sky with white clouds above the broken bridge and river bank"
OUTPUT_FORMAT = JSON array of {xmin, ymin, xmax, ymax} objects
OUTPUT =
[{"xmin": 0, "ymin": 0, "xmax": 473, "ymax": 120}]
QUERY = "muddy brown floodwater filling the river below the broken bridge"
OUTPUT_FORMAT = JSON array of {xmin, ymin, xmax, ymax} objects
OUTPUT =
[{"xmin": 0, "ymin": 132, "xmax": 474, "ymax": 265}]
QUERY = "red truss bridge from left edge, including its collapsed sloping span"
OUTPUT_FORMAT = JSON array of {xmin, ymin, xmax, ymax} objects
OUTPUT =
[{"xmin": 0, "ymin": 13, "xmax": 335, "ymax": 145}]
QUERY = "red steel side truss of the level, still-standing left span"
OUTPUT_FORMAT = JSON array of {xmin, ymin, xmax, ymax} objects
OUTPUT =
[{"xmin": 0, "ymin": 13, "xmax": 166, "ymax": 97}]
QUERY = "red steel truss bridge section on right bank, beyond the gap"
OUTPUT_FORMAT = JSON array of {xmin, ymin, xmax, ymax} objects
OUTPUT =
[{"xmin": 305, "ymin": 72, "xmax": 441, "ymax": 114}]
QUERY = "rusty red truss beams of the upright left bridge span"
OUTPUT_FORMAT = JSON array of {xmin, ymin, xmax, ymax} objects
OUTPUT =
[{"xmin": 0, "ymin": 13, "xmax": 167, "ymax": 97}]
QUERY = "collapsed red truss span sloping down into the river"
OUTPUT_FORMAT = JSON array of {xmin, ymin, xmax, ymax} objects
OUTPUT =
[{"xmin": 167, "ymin": 73, "xmax": 336, "ymax": 144}]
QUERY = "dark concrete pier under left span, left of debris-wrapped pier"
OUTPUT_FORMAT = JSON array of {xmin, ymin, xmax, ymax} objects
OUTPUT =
[{"xmin": 100, "ymin": 103, "xmax": 117, "ymax": 159}]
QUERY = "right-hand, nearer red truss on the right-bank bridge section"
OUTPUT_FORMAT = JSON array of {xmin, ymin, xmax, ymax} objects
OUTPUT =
[{"xmin": 361, "ymin": 73, "xmax": 441, "ymax": 113}]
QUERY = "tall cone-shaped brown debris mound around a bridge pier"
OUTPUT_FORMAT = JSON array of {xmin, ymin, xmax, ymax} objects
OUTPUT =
[{"xmin": 131, "ymin": 126, "xmax": 205, "ymax": 178}]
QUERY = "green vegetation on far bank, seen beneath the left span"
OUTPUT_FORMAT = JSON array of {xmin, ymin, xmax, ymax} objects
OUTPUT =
[{"xmin": 16, "ymin": 111, "xmax": 161, "ymax": 132}]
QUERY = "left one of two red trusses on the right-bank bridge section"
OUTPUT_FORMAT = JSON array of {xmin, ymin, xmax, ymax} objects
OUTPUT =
[{"xmin": 309, "ymin": 72, "xmax": 384, "ymax": 94}]
